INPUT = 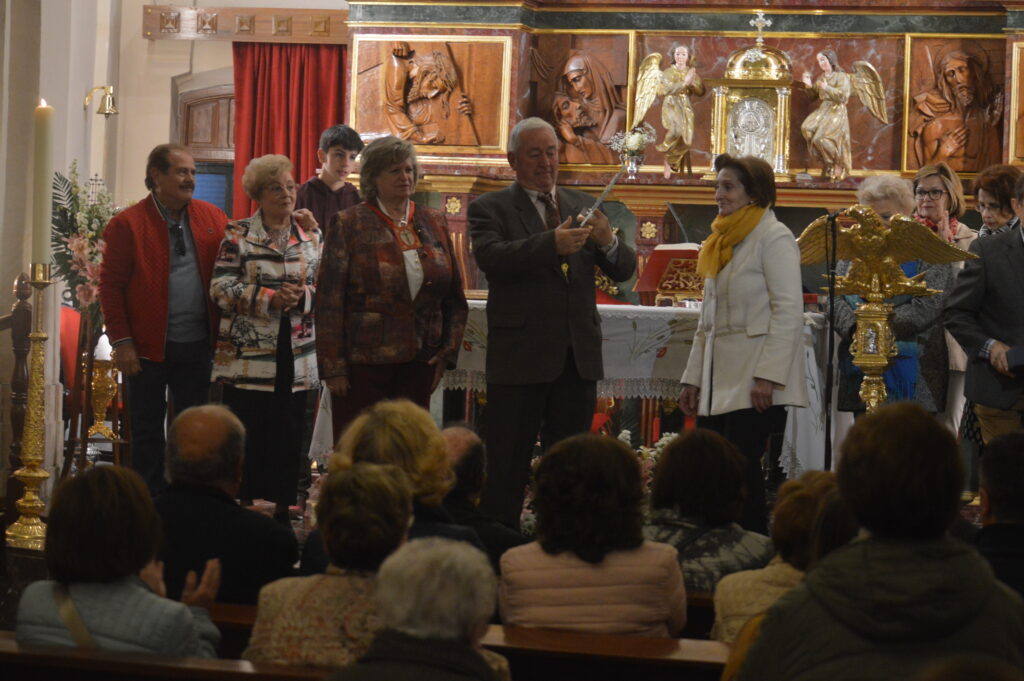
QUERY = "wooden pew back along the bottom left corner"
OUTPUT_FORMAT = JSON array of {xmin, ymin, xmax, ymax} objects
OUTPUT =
[{"xmin": 0, "ymin": 632, "xmax": 329, "ymax": 681}]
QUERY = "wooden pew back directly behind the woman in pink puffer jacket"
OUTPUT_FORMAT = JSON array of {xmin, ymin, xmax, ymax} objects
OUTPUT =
[{"xmin": 482, "ymin": 625, "xmax": 729, "ymax": 681}]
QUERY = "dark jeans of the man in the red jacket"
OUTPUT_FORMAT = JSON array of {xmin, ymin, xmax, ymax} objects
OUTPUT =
[{"xmin": 127, "ymin": 339, "xmax": 212, "ymax": 495}]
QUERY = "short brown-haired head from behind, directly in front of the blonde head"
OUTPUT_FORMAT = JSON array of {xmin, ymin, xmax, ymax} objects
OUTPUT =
[{"xmin": 316, "ymin": 463, "xmax": 413, "ymax": 570}]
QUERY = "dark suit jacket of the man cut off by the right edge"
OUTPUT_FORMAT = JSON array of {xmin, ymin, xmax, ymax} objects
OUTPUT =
[{"xmin": 945, "ymin": 226, "xmax": 1024, "ymax": 410}]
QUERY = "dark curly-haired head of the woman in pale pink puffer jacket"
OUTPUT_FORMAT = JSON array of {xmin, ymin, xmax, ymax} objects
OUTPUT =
[{"xmin": 534, "ymin": 433, "xmax": 643, "ymax": 563}]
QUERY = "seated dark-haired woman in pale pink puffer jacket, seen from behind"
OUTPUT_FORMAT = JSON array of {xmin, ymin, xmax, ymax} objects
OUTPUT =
[{"xmin": 499, "ymin": 433, "xmax": 686, "ymax": 636}]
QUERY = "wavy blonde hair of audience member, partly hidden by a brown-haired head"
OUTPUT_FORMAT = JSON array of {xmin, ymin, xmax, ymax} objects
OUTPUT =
[{"xmin": 329, "ymin": 399, "xmax": 455, "ymax": 506}]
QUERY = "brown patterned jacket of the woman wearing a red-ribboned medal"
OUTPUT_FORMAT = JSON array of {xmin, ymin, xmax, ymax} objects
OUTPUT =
[{"xmin": 315, "ymin": 203, "xmax": 467, "ymax": 379}]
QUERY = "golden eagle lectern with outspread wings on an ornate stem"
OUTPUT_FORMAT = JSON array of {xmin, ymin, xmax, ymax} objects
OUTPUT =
[{"xmin": 797, "ymin": 205, "xmax": 977, "ymax": 413}]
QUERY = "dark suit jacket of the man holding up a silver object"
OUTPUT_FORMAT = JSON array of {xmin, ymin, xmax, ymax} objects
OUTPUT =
[{"xmin": 469, "ymin": 183, "xmax": 636, "ymax": 385}]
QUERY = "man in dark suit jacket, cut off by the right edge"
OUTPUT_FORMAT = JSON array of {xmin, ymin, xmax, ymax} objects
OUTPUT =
[{"xmin": 945, "ymin": 178, "xmax": 1024, "ymax": 444}]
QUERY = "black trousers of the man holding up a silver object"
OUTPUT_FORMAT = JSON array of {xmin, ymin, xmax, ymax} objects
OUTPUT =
[{"xmin": 480, "ymin": 350, "xmax": 597, "ymax": 527}]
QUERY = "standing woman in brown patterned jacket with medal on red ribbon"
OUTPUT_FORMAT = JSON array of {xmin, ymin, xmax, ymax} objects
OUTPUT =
[{"xmin": 316, "ymin": 136, "xmax": 467, "ymax": 437}]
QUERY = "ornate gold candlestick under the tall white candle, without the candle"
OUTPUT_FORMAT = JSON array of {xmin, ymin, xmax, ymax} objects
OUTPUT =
[{"xmin": 6, "ymin": 262, "xmax": 51, "ymax": 551}]
